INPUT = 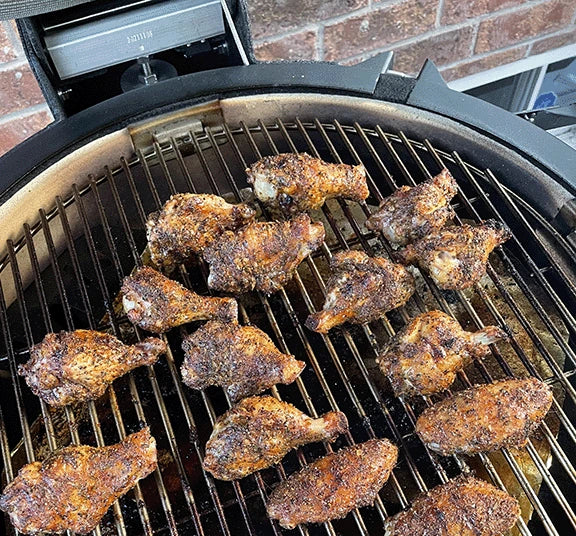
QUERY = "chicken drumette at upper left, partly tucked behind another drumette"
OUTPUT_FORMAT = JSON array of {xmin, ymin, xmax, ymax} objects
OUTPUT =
[{"xmin": 146, "ymin": 194, "xmax": 256, "ymax": 271}]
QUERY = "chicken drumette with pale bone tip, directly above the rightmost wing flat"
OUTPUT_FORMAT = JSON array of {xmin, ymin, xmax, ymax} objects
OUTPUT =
[{"xmin": 376, "ymin": 311, "xmax": 507, "ymax": 396}]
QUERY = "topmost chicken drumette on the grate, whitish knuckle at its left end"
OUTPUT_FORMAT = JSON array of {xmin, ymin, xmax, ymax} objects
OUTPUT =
[{"xmin": 246, "ymin": 153, "xmax": 370, "ymax": 213}]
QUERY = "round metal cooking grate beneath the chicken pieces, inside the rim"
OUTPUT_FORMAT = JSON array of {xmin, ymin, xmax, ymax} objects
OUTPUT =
[{"xmin": 0, "ymin": 120, "xmax": 576, "ymax": 535}]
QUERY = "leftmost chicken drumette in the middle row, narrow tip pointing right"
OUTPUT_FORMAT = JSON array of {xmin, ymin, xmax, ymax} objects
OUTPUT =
[{"xmin": 18, "ymin": 329, "xmax": 166, "ymax": 406}]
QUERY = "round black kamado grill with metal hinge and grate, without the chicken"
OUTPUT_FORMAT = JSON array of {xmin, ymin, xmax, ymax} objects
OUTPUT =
[{"xmin": 0, "ymin": 1, "xmax": 576, "ymax": 536}]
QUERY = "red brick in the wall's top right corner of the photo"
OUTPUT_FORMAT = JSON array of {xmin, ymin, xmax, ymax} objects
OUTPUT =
[{"xmin": 476, "ymin": 0, "xmax": 576, "ymax": 53}]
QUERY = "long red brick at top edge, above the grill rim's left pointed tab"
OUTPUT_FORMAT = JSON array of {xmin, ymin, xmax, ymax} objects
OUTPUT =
[{"xmin": 324, "ymin": 0, "xmax": 438, "ymax": 61}]
